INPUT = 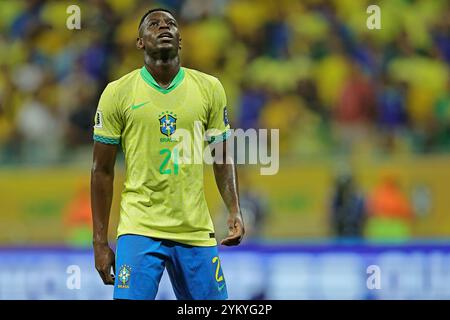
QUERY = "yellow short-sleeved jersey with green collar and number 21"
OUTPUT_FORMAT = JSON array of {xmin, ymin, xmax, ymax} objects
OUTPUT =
[{"xmin": 94, "ymin": 67, "xmax": 230, "ymax": 246}]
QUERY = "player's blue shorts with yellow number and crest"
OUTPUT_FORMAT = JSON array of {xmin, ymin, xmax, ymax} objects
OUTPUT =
[{"xmin": 114, "ymin": 234, "xmax": 228, "ymax": 300}]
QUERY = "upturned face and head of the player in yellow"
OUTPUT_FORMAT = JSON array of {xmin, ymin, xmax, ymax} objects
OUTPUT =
[{"xmin": 138, "ymin": 11, "xmax": 180, "ymax": 51}]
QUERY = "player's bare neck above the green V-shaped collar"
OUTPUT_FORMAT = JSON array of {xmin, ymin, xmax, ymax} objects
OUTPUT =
[{"xmin": 144, "ymin": 55, "xmax": 180, "ymax": 88}]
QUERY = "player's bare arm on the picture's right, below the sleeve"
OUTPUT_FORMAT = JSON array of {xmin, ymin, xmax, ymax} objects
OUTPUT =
[{"xmin": 213, "ymin": 141, "xmax": 245, "ymax": 246}]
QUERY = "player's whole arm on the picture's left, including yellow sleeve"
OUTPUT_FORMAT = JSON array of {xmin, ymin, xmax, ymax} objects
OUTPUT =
[{"xmin": 91, "ymin": 85, "xmax": 123, "ymax": 285}]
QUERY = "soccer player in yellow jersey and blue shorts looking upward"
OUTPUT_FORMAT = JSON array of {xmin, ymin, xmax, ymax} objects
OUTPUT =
[{"xmin": 91, "ymin": 9, "xmax": 244, "ymax": 299}]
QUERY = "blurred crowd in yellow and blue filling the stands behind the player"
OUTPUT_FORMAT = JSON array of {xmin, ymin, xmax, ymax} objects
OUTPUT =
[{"xmin": 0, "ymin": 0, "xmax": 450, "ymax": 163}]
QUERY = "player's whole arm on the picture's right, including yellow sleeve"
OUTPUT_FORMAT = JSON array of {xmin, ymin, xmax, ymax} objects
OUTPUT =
[{"xmin": 207, "ymin": 81, "xmax": 245, "ymax": 246}]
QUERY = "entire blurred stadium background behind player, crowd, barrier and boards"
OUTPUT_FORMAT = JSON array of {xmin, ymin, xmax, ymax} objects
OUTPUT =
[{"xmin": 0, "ymin": 0, "xmax": 450, "ymax": 299}]
